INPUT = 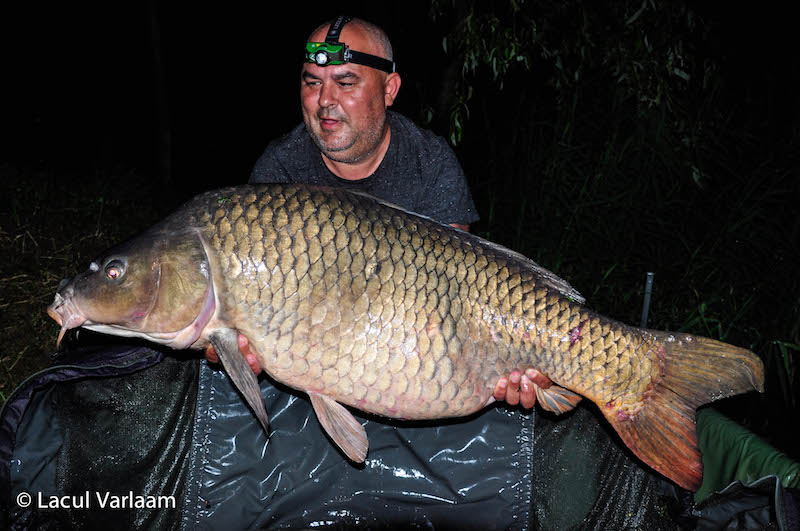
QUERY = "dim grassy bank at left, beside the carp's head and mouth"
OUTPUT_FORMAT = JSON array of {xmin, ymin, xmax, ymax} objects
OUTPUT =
[{"xmin": 0, "ymin": 166, "xmax": 172, "ymax": 402}]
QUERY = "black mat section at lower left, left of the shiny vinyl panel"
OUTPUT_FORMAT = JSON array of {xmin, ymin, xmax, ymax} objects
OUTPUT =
[{"xmin": 0, "ymin": 346, "xmax": 200, "ymax": 529}]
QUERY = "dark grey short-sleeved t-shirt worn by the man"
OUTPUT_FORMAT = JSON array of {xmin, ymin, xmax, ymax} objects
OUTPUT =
[{"xmin": 250, "ymin": 111, "xmax": 478, "ymax": 225}]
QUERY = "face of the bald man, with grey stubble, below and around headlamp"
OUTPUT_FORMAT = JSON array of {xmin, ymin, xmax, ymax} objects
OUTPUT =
[{"xmin": 300, "ymin": 26, "xmax": 393, "ymax": 163}]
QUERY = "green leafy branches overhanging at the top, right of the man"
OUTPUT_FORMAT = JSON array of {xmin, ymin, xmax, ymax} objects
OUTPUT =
[{"xmin": 431, "ymin": 0, "xmax": 716, "ymax": 150}]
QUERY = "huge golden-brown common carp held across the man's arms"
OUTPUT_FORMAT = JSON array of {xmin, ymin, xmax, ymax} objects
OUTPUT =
[{"xmin": 48, "ymin": 185, "xmax": 764, "ymax": 490}]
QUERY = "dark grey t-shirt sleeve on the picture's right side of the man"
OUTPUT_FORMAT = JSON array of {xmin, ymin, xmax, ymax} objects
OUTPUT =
[{"xmin": 420, "ymin": 137, "xmax": 480, "ymax": 225}]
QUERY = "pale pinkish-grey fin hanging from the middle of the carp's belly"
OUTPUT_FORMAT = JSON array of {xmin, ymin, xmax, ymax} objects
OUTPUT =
[{"xmin": 308, "ymin": 391, "xmax": 369, "ymax": 463}]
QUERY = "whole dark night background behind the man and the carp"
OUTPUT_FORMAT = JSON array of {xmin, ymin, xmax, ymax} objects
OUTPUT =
[{"xmin": 0, "ymin": 0, "xmax": 800, "ymax": 455}]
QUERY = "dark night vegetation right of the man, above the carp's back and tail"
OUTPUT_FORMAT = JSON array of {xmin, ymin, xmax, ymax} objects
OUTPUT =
[{"xmin": 431, "ymin": 0, "xmax": 800, "ymax": 454}]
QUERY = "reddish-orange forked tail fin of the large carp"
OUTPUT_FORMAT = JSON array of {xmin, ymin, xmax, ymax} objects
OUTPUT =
[{"xmin": 600, "ymin": 332, "xmax": 764, "ymax": 491}]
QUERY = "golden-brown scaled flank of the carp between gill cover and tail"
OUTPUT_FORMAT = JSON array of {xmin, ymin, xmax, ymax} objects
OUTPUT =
[{"xmin": 205, "ymin": 187, "xmax": 654, "ymax": 418}]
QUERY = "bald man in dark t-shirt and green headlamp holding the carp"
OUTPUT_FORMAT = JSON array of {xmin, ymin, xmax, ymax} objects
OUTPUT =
[{"xmin": 207, "ymin": 17, "xmax": 551, "ymax": 408}]
